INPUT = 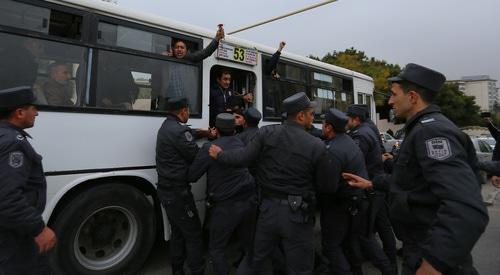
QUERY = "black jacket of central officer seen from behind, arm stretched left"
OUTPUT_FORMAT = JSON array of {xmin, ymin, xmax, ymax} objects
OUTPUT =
[{"xmin": 218, "ymin": 121, "xmax": 337, "ymax": 195}]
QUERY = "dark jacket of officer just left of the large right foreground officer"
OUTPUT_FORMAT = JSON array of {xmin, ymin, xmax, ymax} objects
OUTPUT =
[{"xmin": 349, "ymin": 123, "xmax": 384, "ymax": 179}]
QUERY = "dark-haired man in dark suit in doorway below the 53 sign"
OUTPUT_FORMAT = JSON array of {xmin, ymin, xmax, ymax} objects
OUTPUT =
[{"xmin": 209, "ymin": 69, "xmax": 253, "ymax": 127}]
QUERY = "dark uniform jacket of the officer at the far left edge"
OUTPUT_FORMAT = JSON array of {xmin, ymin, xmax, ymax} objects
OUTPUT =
[{"xmin": 0, "ymin": 122, "xmax": 47, "ymax": 238}]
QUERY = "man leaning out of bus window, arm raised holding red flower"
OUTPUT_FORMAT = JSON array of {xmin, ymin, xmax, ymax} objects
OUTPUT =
[{"xmin": 163, "ymin": 25, "xmax": 224, "ymax": 62}]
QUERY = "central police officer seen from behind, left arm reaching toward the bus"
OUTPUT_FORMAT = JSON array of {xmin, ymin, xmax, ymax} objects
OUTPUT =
[{"xmin": 209, "ymin": 93, "xmax": 337, "ymax": 275}]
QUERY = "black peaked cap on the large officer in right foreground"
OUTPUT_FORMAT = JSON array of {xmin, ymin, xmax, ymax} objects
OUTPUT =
[{"xmin": 388, "ymin": 63, "xmax": 446, "ymax": 92}]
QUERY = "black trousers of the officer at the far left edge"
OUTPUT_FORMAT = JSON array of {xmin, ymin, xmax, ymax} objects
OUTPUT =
[{"xmin": 0, "ymin": 232, "xmax": 51, "ymax": 275}]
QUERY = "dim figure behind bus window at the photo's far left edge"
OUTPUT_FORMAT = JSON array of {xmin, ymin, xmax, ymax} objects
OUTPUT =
[{"xmin": 0, "ymin": 38, "xmax": 43, "ymax": 90}]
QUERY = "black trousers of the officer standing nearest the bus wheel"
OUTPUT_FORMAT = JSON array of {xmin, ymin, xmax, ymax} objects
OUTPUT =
[{"xmin": 158, "ymin": 189, "xmax": 205, "ymax": 273}]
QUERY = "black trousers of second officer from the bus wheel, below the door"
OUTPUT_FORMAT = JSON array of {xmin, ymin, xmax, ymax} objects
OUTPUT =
[{"xmin": 208, "ymin": 194, "xmax": 256, "ymax": 275}]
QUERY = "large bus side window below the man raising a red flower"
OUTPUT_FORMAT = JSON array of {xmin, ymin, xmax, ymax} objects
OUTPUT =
[{"xmin": 96, "ymin": 50, "xmax": 201, "ymax": 115}]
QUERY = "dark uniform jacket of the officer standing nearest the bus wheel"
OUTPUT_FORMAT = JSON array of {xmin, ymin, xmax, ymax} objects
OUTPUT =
[{"xmin": 156, "ymin": 114, "xmax": 199, "ymax": 187}]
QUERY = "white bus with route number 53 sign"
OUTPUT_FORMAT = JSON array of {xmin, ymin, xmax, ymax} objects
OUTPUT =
[{"xmin": 0, "ymin": 0, "xmax": 375, "ymax": 274}]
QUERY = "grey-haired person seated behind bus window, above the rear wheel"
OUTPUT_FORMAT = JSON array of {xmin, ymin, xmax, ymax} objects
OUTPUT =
[{"xmin": 42, "ymin": 62, "xmax": 74, "ymax": 106}]
